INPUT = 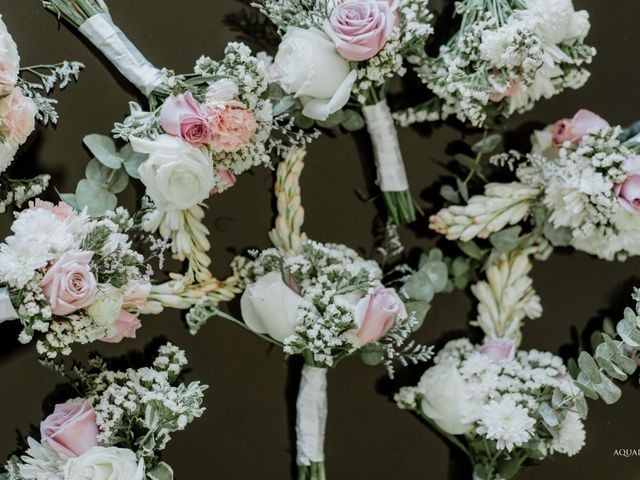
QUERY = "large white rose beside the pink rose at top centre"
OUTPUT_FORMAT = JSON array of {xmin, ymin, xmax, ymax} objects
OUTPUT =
[{"xmin": 274, "ymin": 27, "xmax": 357, "ymax": 120}]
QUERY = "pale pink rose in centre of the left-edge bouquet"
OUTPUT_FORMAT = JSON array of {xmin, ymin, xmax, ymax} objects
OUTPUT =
[{"xmin": 40, "ymin": 252, "xmax": 97, "ymax": 316}]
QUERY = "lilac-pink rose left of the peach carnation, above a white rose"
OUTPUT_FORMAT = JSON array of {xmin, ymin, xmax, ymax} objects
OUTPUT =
[{"xmin": 160, "ymin": 92, "xmax": 210, "ymax": 147}]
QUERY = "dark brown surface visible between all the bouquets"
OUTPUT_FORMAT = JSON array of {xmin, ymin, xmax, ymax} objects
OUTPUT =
[{"xmin": 0, "ymin": 0, "xmax": 640, "ymax": 480}]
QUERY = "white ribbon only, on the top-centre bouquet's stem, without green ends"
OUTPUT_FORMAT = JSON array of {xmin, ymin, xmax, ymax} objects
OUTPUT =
[{"xmin": 362, "ymin": 100, "xmax": 409, "ymax": 192}]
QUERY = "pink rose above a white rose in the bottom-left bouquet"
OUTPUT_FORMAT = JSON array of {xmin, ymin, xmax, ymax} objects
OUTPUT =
[{"xmin": 40, "ymin": 401, "xmax": 99, "ymax": 457}]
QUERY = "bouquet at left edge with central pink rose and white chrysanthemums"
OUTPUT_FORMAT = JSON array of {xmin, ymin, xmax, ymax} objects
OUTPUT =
[{"xmin": 0, "ymin": 200, "xmax": 161, "ymax": 358}]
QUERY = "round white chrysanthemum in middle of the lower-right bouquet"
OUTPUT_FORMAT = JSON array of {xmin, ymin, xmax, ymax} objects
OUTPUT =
[{"xmin": 478, "ymin": 396, "xmax": 536, "ymax": 452}]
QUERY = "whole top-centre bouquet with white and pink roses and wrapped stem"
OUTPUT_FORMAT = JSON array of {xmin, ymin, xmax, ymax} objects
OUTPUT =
[{"xmin": 254, "ymin": 0, "xmax": 433, "ymax": 223}]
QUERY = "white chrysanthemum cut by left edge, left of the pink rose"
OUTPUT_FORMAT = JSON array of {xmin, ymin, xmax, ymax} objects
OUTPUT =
[{"xmin": 0, "ymin": 236, "xmax": 52, "ymax": 288}]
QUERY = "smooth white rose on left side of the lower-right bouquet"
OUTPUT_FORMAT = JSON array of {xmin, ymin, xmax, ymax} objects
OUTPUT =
[{"xmin": 418, "ymin": 363, "xmax": 473, "ymax": 435}]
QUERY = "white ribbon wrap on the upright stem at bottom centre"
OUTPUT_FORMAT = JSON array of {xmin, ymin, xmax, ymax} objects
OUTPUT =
[{"xmin": 296, "ymin": 365, "xmax": 327, "ymax": 465}]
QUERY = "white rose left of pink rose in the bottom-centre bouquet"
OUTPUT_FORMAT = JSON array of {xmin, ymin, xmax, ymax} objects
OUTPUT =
[{"xmin": 240, "ymin": 272, "xmax": 302, "ymax": 342}]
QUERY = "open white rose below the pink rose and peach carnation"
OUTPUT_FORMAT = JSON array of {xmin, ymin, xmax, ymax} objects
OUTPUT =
[{"xmin": 130, "ymin": 135, "xmax": 215, "ymax": 211}]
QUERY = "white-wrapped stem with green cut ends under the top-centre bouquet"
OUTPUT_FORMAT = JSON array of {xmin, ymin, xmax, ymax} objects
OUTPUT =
[{"xmin": 362, "ymin": 99, "xmax": 416, "ymax": 225}]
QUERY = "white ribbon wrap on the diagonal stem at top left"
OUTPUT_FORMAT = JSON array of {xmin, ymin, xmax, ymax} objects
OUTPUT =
[{"xmin": 79, "ymin": 13, "xmax": 163, "ymax": 97}]
